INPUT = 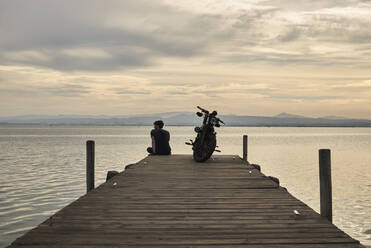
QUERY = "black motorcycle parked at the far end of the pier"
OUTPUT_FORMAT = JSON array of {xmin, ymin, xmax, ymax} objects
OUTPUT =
[{"xmin": 186, "ymin": 106, "xmax": 225, "ymax": 162}]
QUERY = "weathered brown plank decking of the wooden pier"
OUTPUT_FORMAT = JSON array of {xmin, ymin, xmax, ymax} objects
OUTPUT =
[{"xmin": 10, "ymin": 155, "xmax": 362, "ymax": 248}]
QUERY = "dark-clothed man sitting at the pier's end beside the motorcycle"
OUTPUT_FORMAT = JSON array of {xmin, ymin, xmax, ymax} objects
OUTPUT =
[{"xmin": 147, "ymin": 120, "xmax": 171, "ymax": 155}]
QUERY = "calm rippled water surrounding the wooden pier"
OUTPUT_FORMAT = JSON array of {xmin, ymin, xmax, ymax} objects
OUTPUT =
[{"xmin": 0, "ymin": 126, "xmax": 371, "ymax": 247}]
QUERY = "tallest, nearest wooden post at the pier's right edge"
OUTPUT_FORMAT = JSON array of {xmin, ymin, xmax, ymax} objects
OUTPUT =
[{"xmin": 319, "ymin": 149, "xmax": 332, "ymax": 223}]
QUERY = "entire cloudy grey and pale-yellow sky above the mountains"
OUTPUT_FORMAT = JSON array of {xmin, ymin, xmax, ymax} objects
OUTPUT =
[{"xmin": 0, "ymin": 0, "xmax": 371, "ymax": 118}]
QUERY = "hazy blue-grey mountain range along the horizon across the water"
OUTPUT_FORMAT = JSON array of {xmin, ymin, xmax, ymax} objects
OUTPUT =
[{"xmin": 0, "ymin": 112, "xmax": 371, "ymax": 127}]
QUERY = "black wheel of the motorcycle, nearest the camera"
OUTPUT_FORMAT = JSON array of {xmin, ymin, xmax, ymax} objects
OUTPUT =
[{"xmin": 193, "ymin": 134, "xmax": 216, "ymax": 162}]
